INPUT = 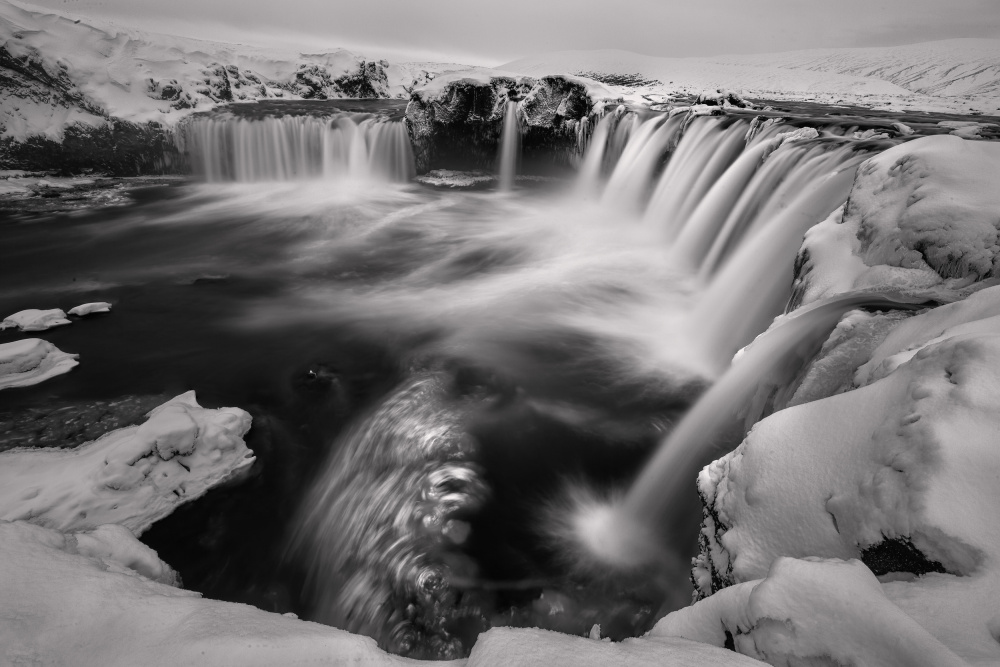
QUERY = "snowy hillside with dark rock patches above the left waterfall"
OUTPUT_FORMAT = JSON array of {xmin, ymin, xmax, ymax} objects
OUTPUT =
[{"xmin": 0, "ymin": 0, "xmax": 456, "ymax": 141}]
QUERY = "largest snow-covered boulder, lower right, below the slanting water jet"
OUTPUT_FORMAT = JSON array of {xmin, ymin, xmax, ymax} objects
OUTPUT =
[{"xmin": 690, "ymin": 287, "xmax": 1000, "ymax": 664}]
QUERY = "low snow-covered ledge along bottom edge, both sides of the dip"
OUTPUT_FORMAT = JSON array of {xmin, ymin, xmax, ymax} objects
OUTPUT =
[{"xmin": 0, "ymin": 521, "xmax": 759, "ymax": 667}]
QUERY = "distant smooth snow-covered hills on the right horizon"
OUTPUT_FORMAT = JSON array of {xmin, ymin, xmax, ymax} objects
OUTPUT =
[{"xmin": 502, "ymin": 39, "xmax": 1000, "ymax": 113}]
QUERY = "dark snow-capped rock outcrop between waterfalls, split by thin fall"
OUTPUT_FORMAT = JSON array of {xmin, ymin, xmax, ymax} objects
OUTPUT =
[{"xmin": 406, "ymin": 70, "xmax": 611, "ymax": 173}]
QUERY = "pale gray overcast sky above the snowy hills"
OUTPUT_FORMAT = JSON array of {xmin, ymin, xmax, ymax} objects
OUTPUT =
[{"xmin": 25, "ymin": 0, "xmax": 1000, "ymax": 65}]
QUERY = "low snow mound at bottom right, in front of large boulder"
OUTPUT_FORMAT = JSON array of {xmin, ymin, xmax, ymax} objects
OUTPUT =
[{"xmin": 650, "ymin": 558, "xmax": 967, "ymax": 667}]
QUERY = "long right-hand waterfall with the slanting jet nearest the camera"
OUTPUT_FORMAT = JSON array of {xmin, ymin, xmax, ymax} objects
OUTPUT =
[{"xmin": 559, "ymin": 107, "xmax": 902, "ymax": 569}]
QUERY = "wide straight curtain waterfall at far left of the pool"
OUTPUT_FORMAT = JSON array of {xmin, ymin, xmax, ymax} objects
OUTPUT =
[{"xmin": 179, "ymin": 113, "xmax": 416, "ymax": 182}]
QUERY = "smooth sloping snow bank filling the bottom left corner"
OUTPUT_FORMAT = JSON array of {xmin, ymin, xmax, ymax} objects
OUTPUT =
[{"xmin": 0, "ymin": 521, "xmax": 438, "ymax": 667}]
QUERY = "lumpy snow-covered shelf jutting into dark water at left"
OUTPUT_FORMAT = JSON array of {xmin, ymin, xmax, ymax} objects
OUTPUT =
[{"xmin": 0, "ymin": 392, "xmax": 254, "ymax": 535}]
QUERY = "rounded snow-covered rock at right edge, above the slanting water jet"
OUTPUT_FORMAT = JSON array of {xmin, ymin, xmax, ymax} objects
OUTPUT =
[{"xmin": 793, "ymin": 135, "xmax": 1000, "ymax": 305}]
